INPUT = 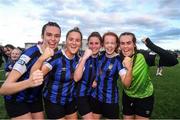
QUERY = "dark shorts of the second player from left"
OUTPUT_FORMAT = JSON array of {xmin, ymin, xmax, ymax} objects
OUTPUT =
[{"xmin": 44, "ymin": 98, "xmax": 77, "ymax": 119}]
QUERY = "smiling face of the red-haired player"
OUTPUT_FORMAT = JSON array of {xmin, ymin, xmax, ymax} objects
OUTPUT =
[{"xmin": 103, "ymin": 35, "xmax": 117, "ymax": 55}]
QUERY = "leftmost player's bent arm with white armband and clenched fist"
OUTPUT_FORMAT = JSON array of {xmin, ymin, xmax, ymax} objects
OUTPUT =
[{"xmin": 0, "ymin": 49, "xmax": 46, "ymax": 95}]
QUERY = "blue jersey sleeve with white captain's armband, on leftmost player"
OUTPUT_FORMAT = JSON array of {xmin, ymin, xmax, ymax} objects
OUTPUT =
[{"xmin": 13, "ymin": 46, "xmax": 37, "ymax": 74}]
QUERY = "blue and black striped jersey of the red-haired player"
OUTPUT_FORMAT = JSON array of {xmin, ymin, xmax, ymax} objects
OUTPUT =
[{"xmin": 92, "ymin": 54, "xmax": 126, "ymax": 103}]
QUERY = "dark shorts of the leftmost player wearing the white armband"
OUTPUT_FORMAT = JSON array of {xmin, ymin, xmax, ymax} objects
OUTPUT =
[{"xmin": 5, "ymin": 99, "xmax": 43, "ymax": 118}]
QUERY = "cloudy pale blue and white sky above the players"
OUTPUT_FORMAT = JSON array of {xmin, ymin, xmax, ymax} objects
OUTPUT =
[{"xmin": 0, "ymin": 0, "xmax": 180, "ymax": 49}]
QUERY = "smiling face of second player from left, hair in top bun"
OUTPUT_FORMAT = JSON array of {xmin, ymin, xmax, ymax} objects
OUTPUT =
[{"xmin": 65, "ymin": 31, "xmax": 82, "ymax": 58}]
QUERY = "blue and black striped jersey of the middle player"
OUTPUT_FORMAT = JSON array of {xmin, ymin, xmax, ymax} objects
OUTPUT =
[{"xmin": 77, "ymin": 56, "xmax": 99, "ymax": 96}]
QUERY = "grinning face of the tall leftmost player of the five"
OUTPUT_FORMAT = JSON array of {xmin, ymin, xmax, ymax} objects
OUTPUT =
[{"xmin": 42, "ymin": 26, "xmax": 61, "ymax": 49}]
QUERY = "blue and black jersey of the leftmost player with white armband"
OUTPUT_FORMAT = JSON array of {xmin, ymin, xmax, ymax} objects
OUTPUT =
[{"xmin": 5, "ymin": 45, "xmax": 42, "ymax": 103}]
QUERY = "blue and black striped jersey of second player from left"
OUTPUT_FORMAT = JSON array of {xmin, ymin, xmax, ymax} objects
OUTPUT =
[{"xmin": 43, "ymin": 50, "xmax": 79, "ymax": 105}]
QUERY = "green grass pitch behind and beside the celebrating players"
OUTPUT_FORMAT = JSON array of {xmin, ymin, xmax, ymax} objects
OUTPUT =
[{"xmin": 0, "ymin": 59, "xmax": 180, "ymax": 119}]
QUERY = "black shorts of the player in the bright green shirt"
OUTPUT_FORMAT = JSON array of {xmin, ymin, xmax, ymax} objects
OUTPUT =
[{"xmin": 122, "ymin": 92, "xmax": 154, "ymax": 118}]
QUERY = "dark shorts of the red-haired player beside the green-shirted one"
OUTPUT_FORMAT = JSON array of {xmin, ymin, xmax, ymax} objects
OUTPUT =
[{"xmin": 91, "ymin": 98, "xmax": 119, "ymax": 119}]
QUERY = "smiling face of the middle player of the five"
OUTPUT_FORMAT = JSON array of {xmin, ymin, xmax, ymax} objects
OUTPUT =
[{"xmin": 88, "ymin": 37, "xmax": 101, "ymax": 55}]
